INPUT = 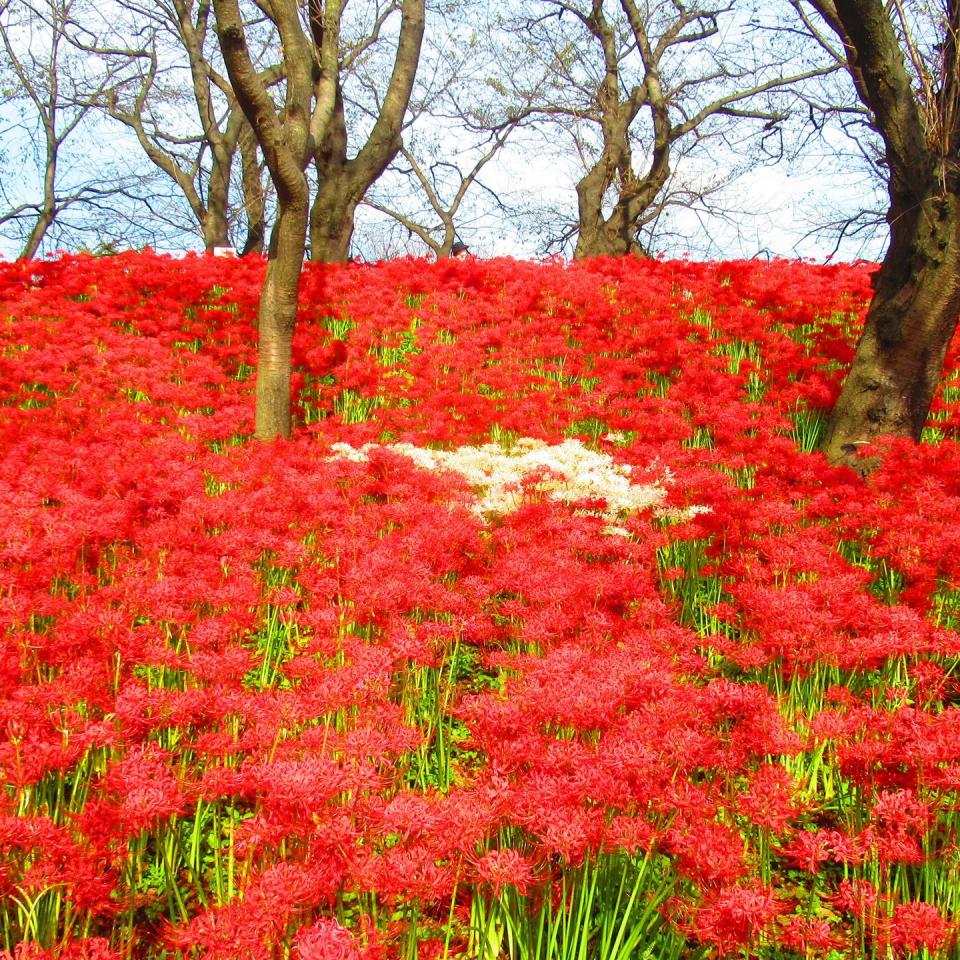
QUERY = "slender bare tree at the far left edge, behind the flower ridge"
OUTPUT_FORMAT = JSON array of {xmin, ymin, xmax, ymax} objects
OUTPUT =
[{"xmin": 0, "ymin": 0, "xmax": 137, "ymax": 259}]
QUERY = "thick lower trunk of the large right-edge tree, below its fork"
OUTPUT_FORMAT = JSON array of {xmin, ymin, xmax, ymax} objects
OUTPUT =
[{"xmin": 823, "ymin": 193, "xmax": 960, "ymax": 470}]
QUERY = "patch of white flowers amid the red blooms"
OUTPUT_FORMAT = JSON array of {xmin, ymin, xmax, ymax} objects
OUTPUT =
[{"xmin": 330, "ymin": 437, "xmax": 702, "ymax": 534}]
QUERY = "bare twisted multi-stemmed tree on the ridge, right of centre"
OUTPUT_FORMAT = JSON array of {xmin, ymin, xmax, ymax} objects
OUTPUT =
[{"xmin": 502, "ymin": 0, "xmax": 837, "ymax": 257}]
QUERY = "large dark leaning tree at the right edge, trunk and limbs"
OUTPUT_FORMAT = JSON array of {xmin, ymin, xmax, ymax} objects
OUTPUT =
[{"xmin": 800, "ymin": 0, "xmax": 960, "ymax": 468}]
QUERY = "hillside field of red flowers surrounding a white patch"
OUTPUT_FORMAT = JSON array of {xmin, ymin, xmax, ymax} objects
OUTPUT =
[{"xmin": 0, "ymin": 253, "xmax": 960, "ymax": 960}]
